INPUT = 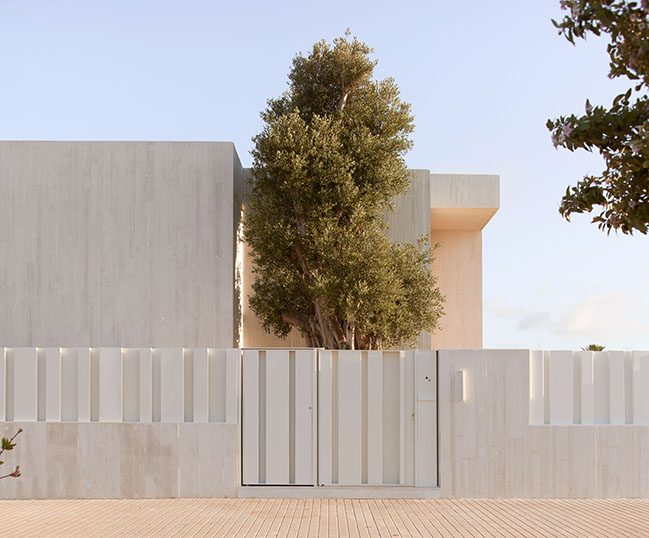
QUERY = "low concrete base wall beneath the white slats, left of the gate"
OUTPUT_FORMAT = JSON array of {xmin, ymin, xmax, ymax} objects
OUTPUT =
[{"xmin": 0, "ymin": 422, "xmax": 240, "ymax": 499}]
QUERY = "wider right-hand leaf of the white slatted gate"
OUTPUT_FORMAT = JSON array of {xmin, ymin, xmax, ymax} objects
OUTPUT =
[{"xmin": 318, "ymin": 350, "xmax": 437, "ymax": 487}]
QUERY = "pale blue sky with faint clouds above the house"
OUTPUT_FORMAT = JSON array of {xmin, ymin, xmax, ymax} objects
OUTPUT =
[{"xmin": 0, "ymin": 0, "xmax": 649, "ymax": 350}]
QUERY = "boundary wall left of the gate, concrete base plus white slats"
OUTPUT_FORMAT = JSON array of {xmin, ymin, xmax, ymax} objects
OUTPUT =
[{"xmin": 0, "ymin": 348, "xmax": 240, "ymax": 499}]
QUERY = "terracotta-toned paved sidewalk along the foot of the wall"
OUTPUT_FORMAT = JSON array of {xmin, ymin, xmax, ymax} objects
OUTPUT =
[{"xmin": 0, "ymin": 499, "xmax": 649, "ymax": 538}]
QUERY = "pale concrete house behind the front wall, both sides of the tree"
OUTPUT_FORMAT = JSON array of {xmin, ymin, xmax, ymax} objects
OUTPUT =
[{"xmin": 0, "ymin": 141, "xmax": 499, "ymax": 349}]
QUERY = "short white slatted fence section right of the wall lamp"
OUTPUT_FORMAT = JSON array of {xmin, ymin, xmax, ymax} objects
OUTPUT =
[{"xmin": 529, "ymin": 351, "xmax": 649, "ymax": 425}]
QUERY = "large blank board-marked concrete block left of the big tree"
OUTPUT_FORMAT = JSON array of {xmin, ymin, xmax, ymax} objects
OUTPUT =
[{"xmin": 0, "ymin": 142, "xmax": 241, "ymax": 347}]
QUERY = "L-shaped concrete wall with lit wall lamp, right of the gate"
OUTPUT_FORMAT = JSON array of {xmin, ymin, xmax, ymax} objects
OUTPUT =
[{"xmin": 438, "ymin": 350, "xmax": 649, "ymax": 498}]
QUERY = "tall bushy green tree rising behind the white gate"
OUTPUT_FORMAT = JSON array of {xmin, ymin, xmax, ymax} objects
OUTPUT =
[{"xmin": 244, "ymin": 37, "xmax": 443, "ymax": 349}]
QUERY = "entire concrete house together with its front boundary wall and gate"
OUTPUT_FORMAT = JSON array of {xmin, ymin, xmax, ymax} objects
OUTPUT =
[{"xmin": 0, "ymin": 142, "xmax": 649, "ymax": 499}]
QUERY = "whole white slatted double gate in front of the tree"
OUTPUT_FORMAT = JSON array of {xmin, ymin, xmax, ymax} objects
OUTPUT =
[{"xmin": 242, "ymin": 349, "xmax": 437, "ymax": 487}]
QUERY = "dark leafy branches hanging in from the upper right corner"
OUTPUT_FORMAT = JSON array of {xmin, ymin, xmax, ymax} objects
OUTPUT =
[{"xmin": 547, "ymin": 0, "xmax": 649, "ymax": 234}]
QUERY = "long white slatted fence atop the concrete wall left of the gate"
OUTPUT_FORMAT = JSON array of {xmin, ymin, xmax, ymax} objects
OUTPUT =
[{"xmin": 0, "ymin": 348, "xmax": 239, "ymax": 422}]
